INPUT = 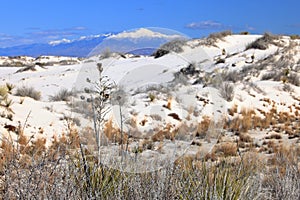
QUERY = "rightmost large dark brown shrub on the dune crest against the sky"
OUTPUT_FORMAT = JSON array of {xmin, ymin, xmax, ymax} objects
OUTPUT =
[{"xmin": 246, "ymin": 33, "xmax": 279, "ymax": 50}]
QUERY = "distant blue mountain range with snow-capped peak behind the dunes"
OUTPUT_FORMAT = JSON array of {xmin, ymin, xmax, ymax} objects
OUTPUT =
[{"xmin": 0, "ymin": 28, "xmax": 182, "ymax": 57}]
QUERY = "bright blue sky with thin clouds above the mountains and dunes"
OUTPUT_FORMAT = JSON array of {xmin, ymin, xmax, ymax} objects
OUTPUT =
[{"xmin": 0, "ymin": 0, "xmax": 300, "ymax": 47}]
